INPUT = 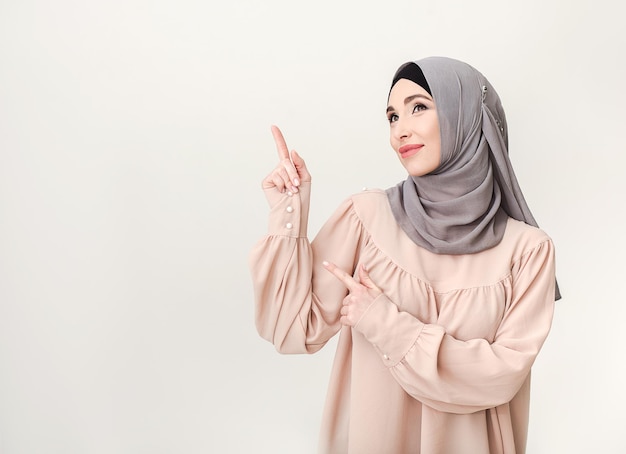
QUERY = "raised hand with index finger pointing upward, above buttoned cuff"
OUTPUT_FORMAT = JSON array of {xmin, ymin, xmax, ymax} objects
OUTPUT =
[{"xmin": 262, "ymin": 126, "xmax": 311, "ymax": 192}]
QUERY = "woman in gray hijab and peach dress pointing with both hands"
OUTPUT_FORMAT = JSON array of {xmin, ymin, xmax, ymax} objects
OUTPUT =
[{"xmin": 250, "ymin": 57, "xmax": 560, "ymax": 454}]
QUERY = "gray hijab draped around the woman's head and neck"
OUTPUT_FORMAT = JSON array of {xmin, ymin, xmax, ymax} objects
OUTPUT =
[{"xmin": 387, "ymin": 57, "xmax": 560, "ymax": 299}]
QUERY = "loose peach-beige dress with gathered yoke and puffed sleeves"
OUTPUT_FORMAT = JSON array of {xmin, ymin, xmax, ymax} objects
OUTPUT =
[{"xmin": 250, "ymin": 183, "xmax": 555, "ymax": 454}]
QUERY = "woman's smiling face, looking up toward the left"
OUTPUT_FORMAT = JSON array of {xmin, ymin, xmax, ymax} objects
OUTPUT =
[{"xmin": 387, "ymin": 79, "xmax": 441, "ymax": 177}]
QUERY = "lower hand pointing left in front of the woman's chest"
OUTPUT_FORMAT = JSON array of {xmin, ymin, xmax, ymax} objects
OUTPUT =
[{"xmin": 324, "ymin": 262, "xmax": 382, "ymax": 326}]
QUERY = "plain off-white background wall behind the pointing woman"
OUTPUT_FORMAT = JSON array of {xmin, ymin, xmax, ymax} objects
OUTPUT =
[{"xmin": 0, "ymin": 0, "xmax": 626, "ymax": 454}]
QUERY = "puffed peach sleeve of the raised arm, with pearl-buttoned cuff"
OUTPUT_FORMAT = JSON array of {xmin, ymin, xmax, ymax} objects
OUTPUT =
[{"xmin": 249, "ymin": 183, "xmax": 362, "ymax": 353}]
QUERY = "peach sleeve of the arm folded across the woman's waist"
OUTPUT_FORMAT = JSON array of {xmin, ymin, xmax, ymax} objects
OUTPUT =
[{"xmin": 355, "ymin": 240, "xmax": 555, "ymax": 413}]
